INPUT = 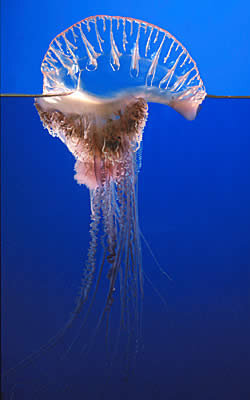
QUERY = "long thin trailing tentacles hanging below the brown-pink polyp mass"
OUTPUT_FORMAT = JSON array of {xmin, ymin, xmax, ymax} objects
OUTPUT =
[{"xmin": 82, "ymin": 152, "xmax": 143, "ymax": 354}]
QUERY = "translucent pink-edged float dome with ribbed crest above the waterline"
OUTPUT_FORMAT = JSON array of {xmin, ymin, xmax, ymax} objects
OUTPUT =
[{"xmin": 41, "ymin": 15, "xmax": 206, "ymax": 119}]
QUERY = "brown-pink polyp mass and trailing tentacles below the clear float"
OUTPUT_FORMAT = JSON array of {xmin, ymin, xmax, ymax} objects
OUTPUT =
[{"xmin": 36, "ymin": 97, "xmax": 147, "ymax": 358}]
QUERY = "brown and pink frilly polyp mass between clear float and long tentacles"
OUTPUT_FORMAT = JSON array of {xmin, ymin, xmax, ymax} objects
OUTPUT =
[{"xmin": 35, "ymin": 92, "xmax": 148, "ymax": 189}]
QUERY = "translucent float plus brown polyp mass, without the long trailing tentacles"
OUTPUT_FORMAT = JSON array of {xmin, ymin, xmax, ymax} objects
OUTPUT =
[{"xmin": 36, "ymin": 15, "xmax": 206, "ymax": 189}]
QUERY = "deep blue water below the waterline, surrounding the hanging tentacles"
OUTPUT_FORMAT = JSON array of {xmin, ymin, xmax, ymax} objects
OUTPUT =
[{"xmin": 1, "ymin": 95, "xmax": 250, "ymax": 400}]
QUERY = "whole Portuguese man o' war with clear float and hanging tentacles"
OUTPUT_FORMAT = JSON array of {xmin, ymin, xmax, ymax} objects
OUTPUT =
[{"xmin": 35, "ymin": 15, "xmax": 206, "ymax": 356}]
